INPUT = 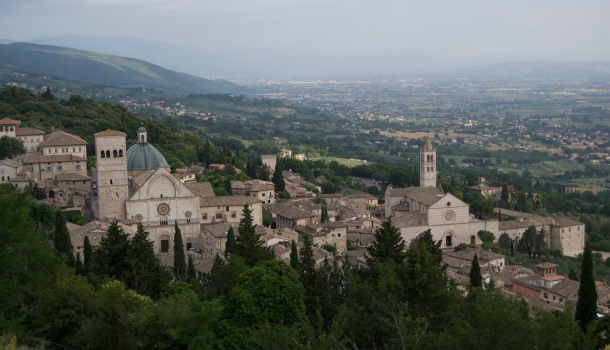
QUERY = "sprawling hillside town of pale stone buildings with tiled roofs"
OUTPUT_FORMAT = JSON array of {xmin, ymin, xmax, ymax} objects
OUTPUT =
[{"xmin": 0, "ymin": 118, "xmax": 610, "ymax": 313}]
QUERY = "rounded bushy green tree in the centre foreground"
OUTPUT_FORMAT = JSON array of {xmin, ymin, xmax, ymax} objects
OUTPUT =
[{"xmin": 225, "ymin": 260, "xmax": 305, "ymax": 327}]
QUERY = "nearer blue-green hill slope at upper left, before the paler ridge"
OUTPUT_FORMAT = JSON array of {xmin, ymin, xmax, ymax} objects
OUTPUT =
[{"xmin": 0, "ymin": 43, "xmax": 244, "ymax": 94}]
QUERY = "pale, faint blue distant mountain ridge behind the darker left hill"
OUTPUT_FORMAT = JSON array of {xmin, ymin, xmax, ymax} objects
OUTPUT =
[{"xmin": 31, "ymin": 35, "xmax": 253, "ymax": 79}]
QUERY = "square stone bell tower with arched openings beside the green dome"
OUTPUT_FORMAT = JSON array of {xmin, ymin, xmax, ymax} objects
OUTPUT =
[{"xmin": 93, "ymin": 129, "xmax": 129, "ymax": 220}]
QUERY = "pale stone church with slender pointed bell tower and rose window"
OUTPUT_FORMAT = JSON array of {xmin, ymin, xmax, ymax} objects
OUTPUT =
[{"xmin": 385, "ymin": 138, "xmax": 499, "ymax": 249}]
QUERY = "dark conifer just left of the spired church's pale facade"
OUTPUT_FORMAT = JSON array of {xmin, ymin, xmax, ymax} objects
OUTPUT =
[{"xmin": 367, "ymin": 218, "xmax": 406, "ymax": 264}]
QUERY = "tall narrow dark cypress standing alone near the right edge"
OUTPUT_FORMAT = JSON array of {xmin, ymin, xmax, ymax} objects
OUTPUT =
[{"xmin": 575, "ymin": 241, "xmax": 597, "ymax": 331}]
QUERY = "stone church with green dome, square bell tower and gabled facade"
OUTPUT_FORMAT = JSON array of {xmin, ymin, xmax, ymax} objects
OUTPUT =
[{"xmin": 93, "ymin": 127, "xmax": 200, "ymax": 253}]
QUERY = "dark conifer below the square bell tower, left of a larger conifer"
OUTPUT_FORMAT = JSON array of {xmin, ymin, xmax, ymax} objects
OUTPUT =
[{"xmin": 93, "ymin": 220, "xmax": 129, "ymax": 280}]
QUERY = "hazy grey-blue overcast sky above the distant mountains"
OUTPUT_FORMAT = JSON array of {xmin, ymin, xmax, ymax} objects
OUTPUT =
[{"xmin": 0, "ymin": 0, "xmax": 610, "ymax": 72}]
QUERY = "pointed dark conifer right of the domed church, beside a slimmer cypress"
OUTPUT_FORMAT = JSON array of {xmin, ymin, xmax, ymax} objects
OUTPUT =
[{"xmin": 235, "ymin": 204, "xmax": 274, "ymax": 266}]
